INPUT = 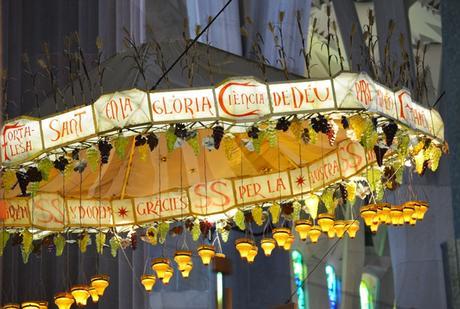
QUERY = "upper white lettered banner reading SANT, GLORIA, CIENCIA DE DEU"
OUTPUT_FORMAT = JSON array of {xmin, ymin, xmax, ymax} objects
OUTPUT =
[{"xmin": 0, "ymin": 73, "xmax": 444, "ymax": 165}]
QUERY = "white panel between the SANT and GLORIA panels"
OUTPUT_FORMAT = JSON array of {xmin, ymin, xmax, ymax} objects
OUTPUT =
[{"xmin": 93, "ymin": 89, "xmax": 151, "ymax": 132}]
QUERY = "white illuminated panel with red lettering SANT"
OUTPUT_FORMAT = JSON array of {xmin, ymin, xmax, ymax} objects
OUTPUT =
[{"xmin": 42, "ymin": 105, "xmax": 96, "ymax": 148}]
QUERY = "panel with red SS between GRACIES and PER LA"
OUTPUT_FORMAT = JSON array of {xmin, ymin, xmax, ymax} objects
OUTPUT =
[{"xmin": 188, "ymin": 179, "xmax": 235, "ymax": 215}]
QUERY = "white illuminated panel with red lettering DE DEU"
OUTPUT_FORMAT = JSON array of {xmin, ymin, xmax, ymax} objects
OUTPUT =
[{"xmin": 269, "ymin": 79, "xmax": 335, "ymax": 113}]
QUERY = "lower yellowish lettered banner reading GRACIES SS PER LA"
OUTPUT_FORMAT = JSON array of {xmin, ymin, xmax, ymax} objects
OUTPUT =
[{"xmin": 4, "ymin": 140, "xmax": 392, "ymax": 231}]
